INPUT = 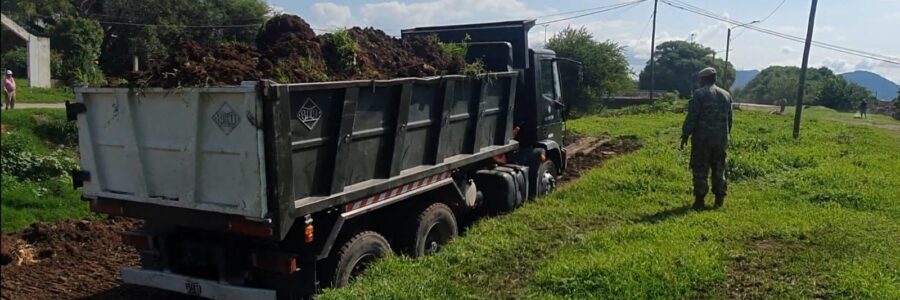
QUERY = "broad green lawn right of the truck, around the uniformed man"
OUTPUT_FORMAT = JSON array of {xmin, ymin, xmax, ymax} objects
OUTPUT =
[{"xmin": 320, "ymin": 108, "xmax": 900, "ymax": 299}]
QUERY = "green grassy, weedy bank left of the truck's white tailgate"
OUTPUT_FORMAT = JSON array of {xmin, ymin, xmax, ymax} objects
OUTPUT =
[{"xmin": 0, "ymin": 109, "xmax": 93, "ymax": 232}]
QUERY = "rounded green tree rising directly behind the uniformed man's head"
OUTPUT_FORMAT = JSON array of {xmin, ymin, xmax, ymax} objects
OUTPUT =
[{"xmin": 639, "ymin": 41, "xmax": 735, "ymax": 97}]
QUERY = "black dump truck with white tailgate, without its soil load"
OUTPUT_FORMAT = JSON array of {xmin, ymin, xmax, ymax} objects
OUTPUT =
[{"xmin": 66, "ymin": 20, "xmax": 578, "ymax": 299}]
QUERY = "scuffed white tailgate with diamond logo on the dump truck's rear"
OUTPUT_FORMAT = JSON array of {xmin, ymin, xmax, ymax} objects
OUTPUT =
[{"xmin": 76, "ymin": 87, "xmax": 266, "ymax": 218}]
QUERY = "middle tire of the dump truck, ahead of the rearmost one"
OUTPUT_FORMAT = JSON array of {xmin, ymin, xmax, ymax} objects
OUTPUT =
[{"xmin": 409, "ymin": 202, "xmax": 459, "ymax": 257}]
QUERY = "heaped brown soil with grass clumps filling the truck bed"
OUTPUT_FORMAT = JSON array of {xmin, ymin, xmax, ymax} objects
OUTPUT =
[{"xmin": 139, "ymin": 15, "xmax": 466, "ymax": 88}]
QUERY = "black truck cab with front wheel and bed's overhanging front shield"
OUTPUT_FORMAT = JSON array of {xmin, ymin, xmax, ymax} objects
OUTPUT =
[{"xmin": 402, "ymin": 20, "xmax": 580, "ymax": 197}]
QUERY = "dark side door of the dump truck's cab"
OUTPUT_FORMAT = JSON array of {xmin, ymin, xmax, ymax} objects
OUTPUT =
[{"xmin": 537, "ymin": 56, "xmax": 565, "ymax": 146}]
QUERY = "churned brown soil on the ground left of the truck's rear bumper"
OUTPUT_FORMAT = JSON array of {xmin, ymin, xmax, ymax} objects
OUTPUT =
[{"xmin": 0, "ymin": 218, "xmax": 176, "ymax": 299}]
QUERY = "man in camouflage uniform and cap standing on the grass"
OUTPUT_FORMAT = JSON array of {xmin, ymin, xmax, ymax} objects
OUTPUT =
[{"xmin": 681, "ymin": 68, "xmax": 732, "ymax": 209}]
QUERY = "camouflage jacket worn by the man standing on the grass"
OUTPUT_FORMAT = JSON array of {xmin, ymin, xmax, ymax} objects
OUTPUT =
[{"xmin": 681, "ymin": 85, "xmax": 732, "ymax": 144}]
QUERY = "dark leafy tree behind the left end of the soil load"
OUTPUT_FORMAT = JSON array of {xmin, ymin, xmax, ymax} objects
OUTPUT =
[{"xmin": 78, "ymin": 0, "xmax": 269, "ymax": 76}]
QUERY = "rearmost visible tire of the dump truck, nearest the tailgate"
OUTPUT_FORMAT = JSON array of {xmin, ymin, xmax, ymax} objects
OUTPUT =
[{"xmin": 332, "ymin": 231, "xmax": 391, "ymax": 288}]
